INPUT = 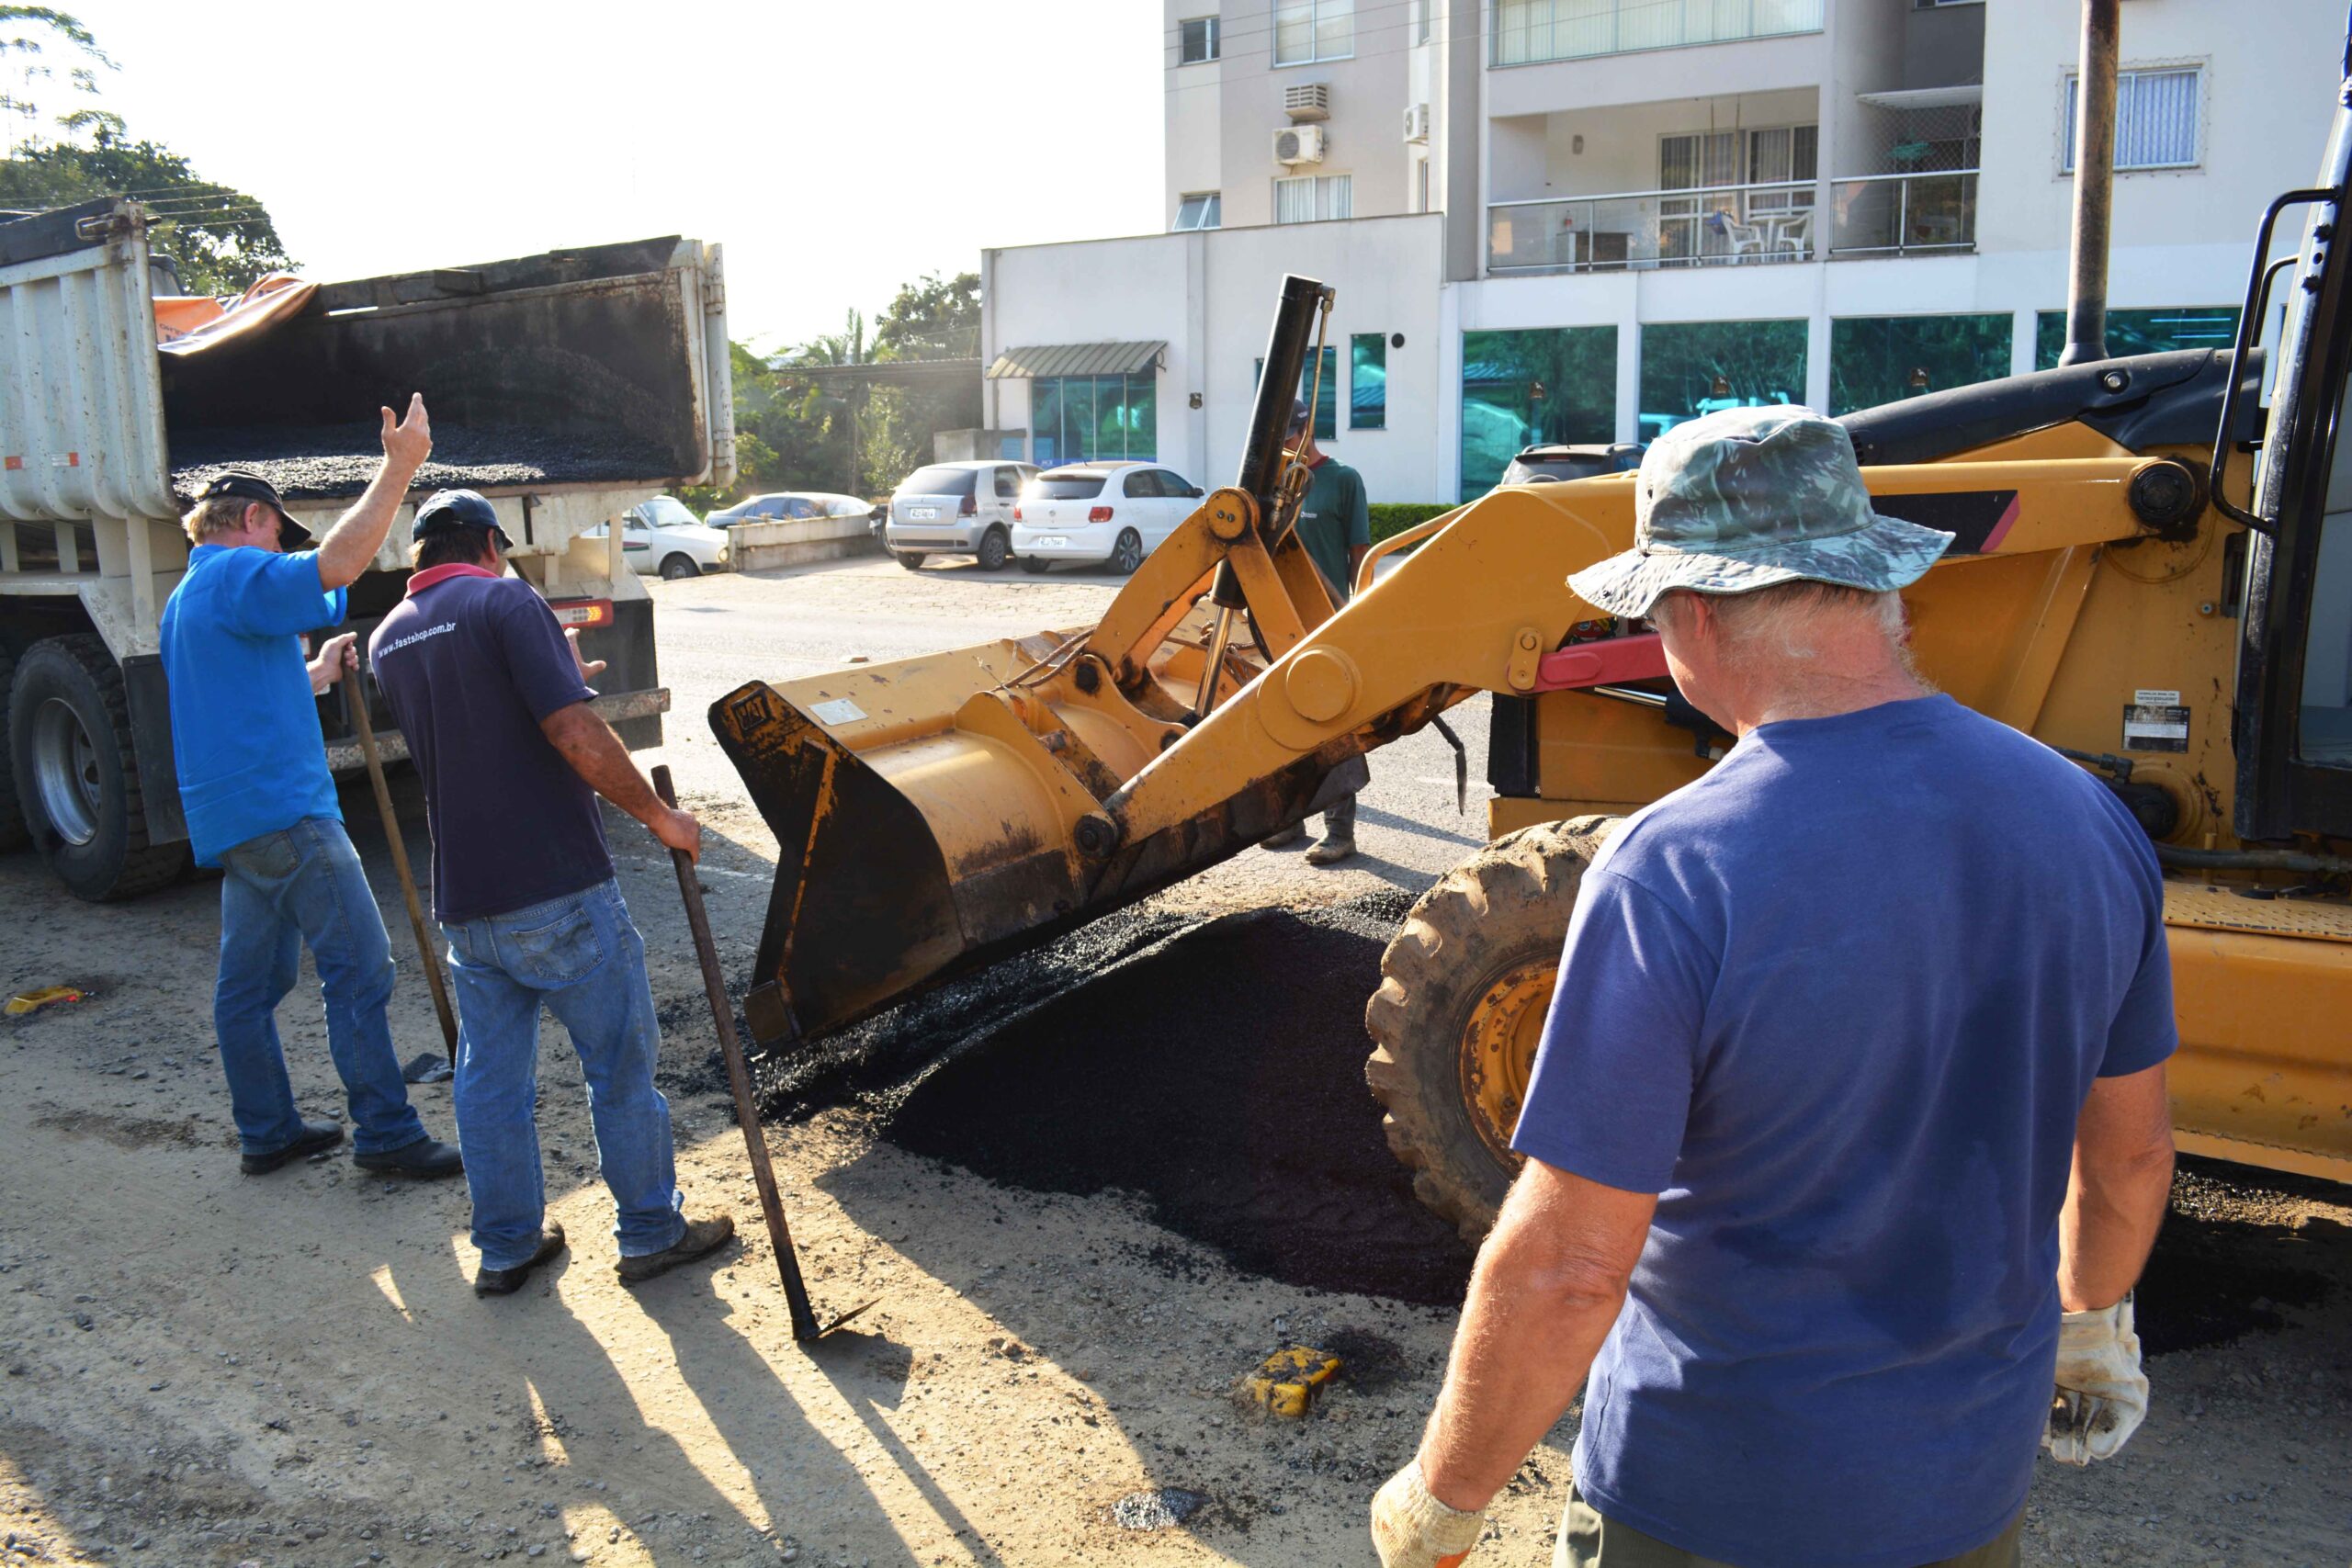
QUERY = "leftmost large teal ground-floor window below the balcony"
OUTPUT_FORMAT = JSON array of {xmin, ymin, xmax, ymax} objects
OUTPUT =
[{"xmin": 1461, "ymin": 322, "xmax": 1618, "ymax": 501}]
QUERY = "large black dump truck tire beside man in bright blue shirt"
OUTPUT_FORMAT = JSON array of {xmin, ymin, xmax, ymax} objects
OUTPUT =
[{"xmin": 7, "ymin": 632, "xmax": 188, "ymax": 903}]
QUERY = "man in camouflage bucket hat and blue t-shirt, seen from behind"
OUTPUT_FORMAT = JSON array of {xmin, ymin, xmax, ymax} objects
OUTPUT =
[{"xmin": 1374, "ymin": 407, "xmax": 2176, "ymax": 1568}]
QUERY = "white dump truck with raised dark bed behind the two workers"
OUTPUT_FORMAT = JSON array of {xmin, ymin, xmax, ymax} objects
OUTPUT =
[{"xmin": 0, "ymin": 200, "xmax": 734, "ymax": 898}]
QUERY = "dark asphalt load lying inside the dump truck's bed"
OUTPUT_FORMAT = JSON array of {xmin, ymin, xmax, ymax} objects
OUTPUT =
[{"xmin": 172, "ymin": 421, "xmax": 673, "ymax": 503}]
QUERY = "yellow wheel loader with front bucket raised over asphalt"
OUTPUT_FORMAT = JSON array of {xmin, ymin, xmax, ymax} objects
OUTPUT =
[{"xmin": 710, "ymin": 138, "xmax": 2352, "ymax": 1235}]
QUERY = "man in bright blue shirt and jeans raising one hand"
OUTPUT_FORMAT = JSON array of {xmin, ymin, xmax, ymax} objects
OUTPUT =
[{"xmin": 163, "ymin": 398, "xmax": 463, "ymax": 1178}]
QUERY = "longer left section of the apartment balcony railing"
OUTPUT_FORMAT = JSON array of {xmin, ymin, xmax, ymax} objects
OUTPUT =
[{"xmin": 1487, "ymin": 179, "xmax": 1815, "ymax": 273}]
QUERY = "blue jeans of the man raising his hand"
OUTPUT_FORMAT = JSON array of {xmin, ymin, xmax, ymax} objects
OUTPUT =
[{"xmin": 211, "ymin": 816, "xmax": 425, "ymax": 1155}]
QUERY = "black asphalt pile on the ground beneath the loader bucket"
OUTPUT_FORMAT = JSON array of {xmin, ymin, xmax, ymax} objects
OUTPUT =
[{"xmin": 865, "ymin": 891, "xmax": 1473, "ymax": 1307}]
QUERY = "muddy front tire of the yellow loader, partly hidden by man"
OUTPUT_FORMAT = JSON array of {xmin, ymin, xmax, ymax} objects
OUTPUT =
[{"xmin": 1364, "ymin": 816, "xmax": 1621, "ymax": 1241}]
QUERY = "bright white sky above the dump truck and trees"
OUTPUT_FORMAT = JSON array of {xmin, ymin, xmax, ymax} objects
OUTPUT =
[{"xmin": 56, "ymin": 0, "xmax": 1162, "ymax": 350}]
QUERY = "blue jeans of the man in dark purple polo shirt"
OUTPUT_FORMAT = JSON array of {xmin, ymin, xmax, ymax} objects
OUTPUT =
[{"xmin": 442, "ymin": 879, "xmax": 687, "ymax": 1269}]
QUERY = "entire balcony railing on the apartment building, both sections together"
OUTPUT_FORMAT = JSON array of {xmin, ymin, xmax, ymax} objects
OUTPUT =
[{"xmin": 1487, "ymin": 169, "xmax": 1975, "ymax": 273}]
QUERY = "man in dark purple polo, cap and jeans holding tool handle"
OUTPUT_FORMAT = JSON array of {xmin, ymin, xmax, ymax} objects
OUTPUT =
[{"xmin": 369, "ymin": 489, "xmax": 734, "ymax": 1295}]
